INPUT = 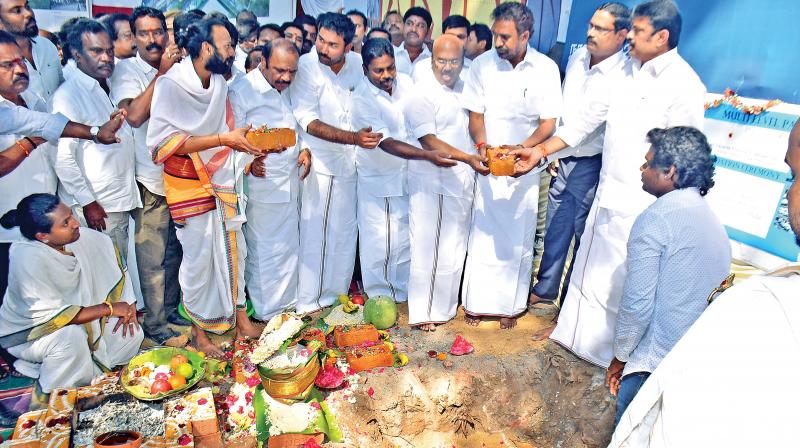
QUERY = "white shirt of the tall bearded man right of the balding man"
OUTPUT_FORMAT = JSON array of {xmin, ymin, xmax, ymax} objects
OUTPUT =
[{"xmin": 462, "ymin": 47, "xmax": 561, "ymax": 145}]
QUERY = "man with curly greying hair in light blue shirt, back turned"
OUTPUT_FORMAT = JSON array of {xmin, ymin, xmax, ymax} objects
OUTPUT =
[{"xmin": 606, "ymin": 126, "xmax": 731, "ymax": 424}]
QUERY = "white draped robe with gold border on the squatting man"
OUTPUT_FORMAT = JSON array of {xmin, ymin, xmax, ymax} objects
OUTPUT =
[{"xmin": 0, "ymin": 228, "xmax": 143, "ymax": 392}]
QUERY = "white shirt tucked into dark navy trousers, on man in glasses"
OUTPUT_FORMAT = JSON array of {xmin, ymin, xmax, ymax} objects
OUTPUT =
[{"xmin": 555, "ymin": 47, "xmax": 627, "ymax": 158}]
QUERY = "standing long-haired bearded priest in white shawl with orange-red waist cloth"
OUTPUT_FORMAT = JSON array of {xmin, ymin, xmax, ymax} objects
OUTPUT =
[{"xmin": 147, "ymin": 18, "xmax": 260, "ymax": 356}]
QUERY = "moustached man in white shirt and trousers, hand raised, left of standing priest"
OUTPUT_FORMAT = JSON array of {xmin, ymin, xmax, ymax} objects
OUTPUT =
[{"xmin": 108, "ymin": 6, "xmax": 188, "ymax": 345}]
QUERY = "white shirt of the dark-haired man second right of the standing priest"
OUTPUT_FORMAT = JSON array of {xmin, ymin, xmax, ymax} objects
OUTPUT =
[{"xmin": 289, "ymin": 49, "xmax": 364, "ymax": 176}]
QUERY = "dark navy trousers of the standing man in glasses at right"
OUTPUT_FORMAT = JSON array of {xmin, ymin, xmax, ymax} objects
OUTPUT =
[{"xmin": 531, "ymin": 154, "xmax": 602, "ymax": 300}]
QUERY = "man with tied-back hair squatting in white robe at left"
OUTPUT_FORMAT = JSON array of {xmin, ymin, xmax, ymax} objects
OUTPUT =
[{"xmin": 0, "ymin": 193, "xmax": 142, "ymax": 393}]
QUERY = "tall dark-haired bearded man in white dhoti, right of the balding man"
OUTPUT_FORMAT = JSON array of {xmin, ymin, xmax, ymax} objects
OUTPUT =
[{"xmin": 462, "ymin": 3, "xmax": 561, "ymax": 328}]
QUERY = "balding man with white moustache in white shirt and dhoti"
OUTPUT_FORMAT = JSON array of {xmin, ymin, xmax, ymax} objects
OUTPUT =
[{"xmin": 405, "ymin": 35, "xmax": 489, "ymax": 331}]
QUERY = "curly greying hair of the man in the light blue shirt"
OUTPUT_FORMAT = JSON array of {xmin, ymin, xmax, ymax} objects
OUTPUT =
[{"xmin": 647, "ymin": 126, "xmax": 717, "ymax": 196}]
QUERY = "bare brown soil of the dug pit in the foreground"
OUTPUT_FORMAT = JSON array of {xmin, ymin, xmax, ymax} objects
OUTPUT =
[{"xmin": 326, "ymin": 305, "xmax": 615, "ymax": 448}]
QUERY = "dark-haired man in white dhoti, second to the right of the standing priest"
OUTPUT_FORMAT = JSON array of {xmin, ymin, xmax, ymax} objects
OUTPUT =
[{"xmin": 289, "ymin": 13, "xmax": 382, "ymax": 313}]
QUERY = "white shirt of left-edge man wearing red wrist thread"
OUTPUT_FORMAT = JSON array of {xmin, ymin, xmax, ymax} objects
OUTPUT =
[{"xmin": 0, "ymin": 90, "xmax": 57, "ymax": 243}]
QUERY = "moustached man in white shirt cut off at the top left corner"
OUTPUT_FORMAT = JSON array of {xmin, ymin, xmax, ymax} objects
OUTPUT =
[{"xmin": 0, "ymin": 0, "xmax": 64, "ymax": 101}]
